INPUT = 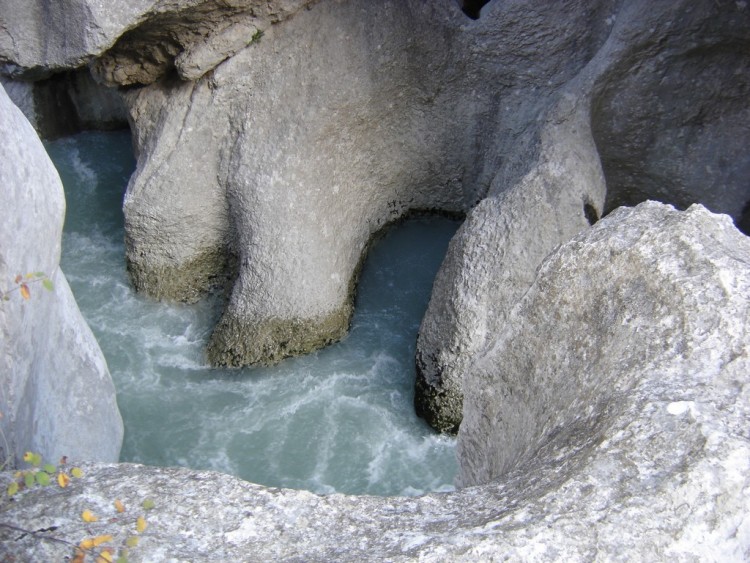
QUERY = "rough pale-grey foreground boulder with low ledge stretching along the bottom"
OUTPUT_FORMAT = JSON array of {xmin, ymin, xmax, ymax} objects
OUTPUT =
[{"xmin": 0, "ymin": 203, "xmax": 750, "ymax": 561}]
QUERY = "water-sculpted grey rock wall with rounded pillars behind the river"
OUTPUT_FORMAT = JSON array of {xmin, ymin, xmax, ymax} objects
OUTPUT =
[{"xmin": 0, "ymin": 0, "xmax": 750, "ymax": 418}]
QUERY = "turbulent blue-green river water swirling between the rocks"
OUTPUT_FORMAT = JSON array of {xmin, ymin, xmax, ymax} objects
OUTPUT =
[{"xmin": 47, "ymin": 132, "xmax": 458, "ymax": 495}]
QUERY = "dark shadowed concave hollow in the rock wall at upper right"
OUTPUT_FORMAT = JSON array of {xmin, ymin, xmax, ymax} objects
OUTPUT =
[{"xmin": 591, "ymin": 4, "xmax": 750, "ymax": 220}]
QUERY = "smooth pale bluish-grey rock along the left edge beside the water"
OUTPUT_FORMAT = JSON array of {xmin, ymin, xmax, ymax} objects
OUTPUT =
[{"xmin": 0, "ymin": 83, "xmax": 123, "ymax": 466}]
